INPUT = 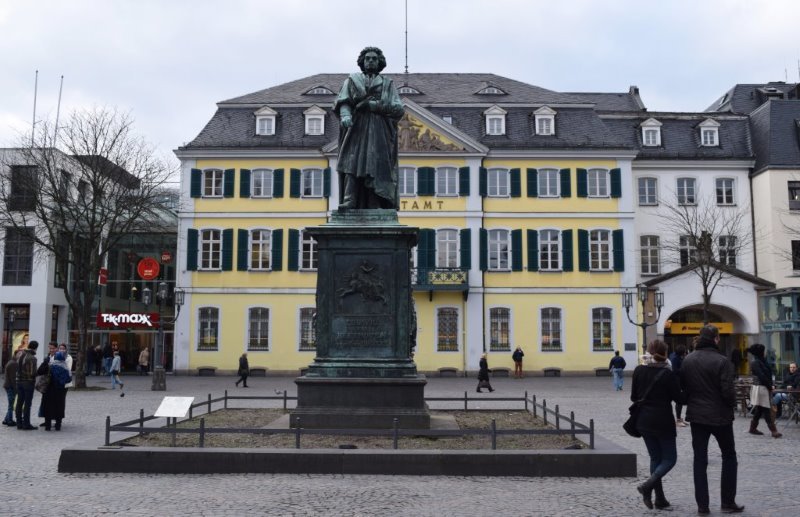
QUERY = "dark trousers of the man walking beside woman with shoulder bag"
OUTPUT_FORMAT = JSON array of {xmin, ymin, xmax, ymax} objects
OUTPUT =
[{"xmin": 692, "ymin": 422, "xmax": 739, "ymax": 508}]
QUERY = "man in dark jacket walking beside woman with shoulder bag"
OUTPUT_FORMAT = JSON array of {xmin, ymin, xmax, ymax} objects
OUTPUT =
[{"xmin": 680, "ymin": 325, "xmax": 744, "ymax": 515}]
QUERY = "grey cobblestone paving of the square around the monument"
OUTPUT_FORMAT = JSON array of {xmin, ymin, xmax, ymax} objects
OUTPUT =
[{"xmin": 0, "ymin": 376, "xmax": 800, "ymax": 517}]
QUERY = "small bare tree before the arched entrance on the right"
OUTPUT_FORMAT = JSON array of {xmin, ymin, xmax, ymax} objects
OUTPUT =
[{"xmin": 660, "ymin": 197, "xmax": 753, "ymax": 323}]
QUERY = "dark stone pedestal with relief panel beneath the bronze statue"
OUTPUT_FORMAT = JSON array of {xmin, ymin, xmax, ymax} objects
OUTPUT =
[{"xmin": 291, "ymin": 210, "xmax": 430, "ymax": 428}]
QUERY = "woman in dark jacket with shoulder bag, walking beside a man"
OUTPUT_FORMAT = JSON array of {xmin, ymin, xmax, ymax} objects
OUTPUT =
[{"xmin": 631, "ymin": 340, "xmax": 686, "ymax": 509}]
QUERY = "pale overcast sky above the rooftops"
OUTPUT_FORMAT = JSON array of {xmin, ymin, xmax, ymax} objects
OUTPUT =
[{"xmin": 0, "ymin": 0, "xmax": 800, "ymax": 167}]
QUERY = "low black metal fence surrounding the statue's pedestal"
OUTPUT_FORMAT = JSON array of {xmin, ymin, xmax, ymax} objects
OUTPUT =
[{"xmin": 105, "ymin": 390, "xmax": 594, "ymax": 450}]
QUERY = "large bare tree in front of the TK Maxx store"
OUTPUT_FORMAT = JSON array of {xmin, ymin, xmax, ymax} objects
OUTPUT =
[{"xmin": 0, "ymin": 108, "xmax": 174, "ymax": 387}]
